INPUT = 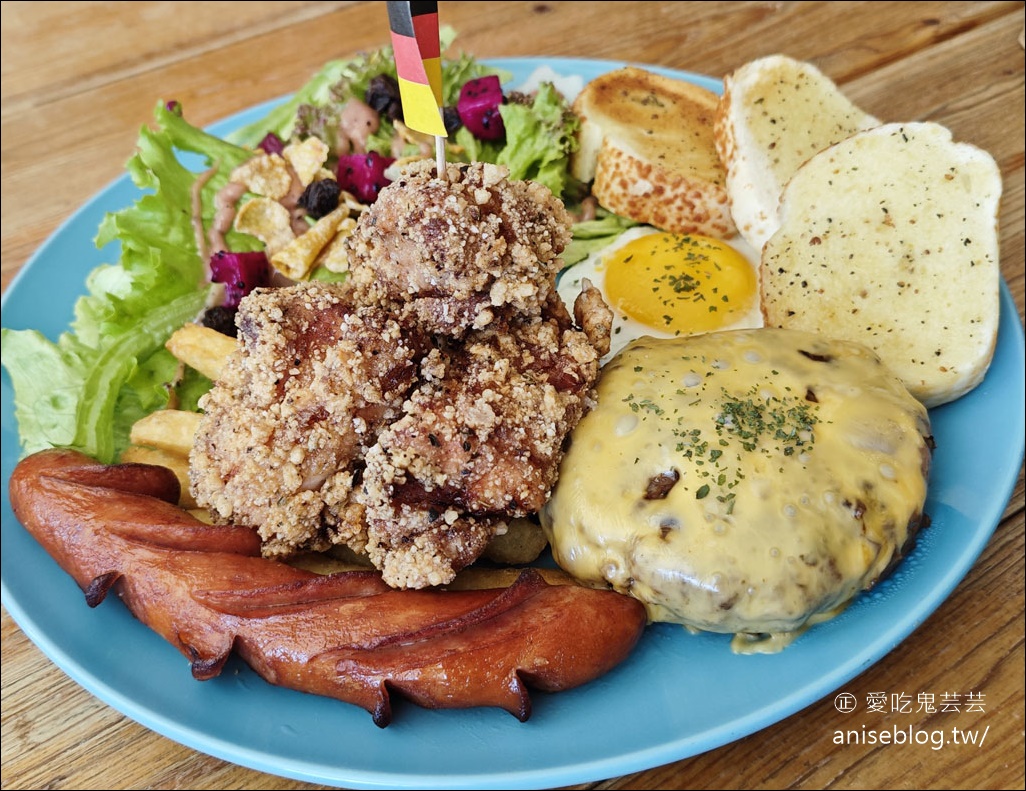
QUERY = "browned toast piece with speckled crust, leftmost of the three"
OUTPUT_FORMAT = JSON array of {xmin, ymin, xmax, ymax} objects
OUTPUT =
[{"xmin": 570, "ymin": 67, "xmax": 737, "ymax": 238}]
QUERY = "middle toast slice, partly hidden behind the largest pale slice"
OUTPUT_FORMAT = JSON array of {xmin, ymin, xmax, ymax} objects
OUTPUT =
[{"xmin": 715, "ymin": 54, "xmax": 879, "ymax": 250}]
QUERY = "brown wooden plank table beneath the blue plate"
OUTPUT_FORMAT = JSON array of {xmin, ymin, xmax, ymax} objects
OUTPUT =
[{"xmin": 2, "ymin": 1, "xmax": 1024, "ymax": 789}]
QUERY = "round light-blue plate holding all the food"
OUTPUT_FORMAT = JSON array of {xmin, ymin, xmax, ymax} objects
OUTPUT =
[{"xmin": 0, "ymin": 58, "xmax": 1026, "ymax": 789}]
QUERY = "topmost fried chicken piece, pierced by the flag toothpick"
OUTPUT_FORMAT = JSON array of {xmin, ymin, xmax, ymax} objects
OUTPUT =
[{"xmin": 347, "ymin": 161, "xmax": 570, "ymax": 338}]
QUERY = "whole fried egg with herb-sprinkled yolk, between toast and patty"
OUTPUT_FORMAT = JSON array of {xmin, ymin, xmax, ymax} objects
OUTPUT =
[{"xmin": 557, "ymin": 226, "xmax": 762, "ymax": 359}]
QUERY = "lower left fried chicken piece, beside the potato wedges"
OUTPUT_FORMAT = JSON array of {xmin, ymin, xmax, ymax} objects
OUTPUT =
[{"xmin": 190, "ymin": 282, "xmax": 426, "ymax": 555}]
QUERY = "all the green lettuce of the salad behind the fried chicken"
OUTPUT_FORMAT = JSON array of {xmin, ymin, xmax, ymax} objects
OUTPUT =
[{"xmin": 0, "ymin": 38, "xmax": 626, "ymax": 463}]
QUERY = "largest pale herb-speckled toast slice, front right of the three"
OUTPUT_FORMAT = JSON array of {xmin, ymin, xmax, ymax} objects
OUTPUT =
[{"xmin": 760, "ymin": 123, "xmax": 1002, "ymax": 406}]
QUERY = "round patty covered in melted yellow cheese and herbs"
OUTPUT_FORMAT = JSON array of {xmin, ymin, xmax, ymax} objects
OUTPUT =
[{"xmin": 541, "ymin": 328, "xmax": 933, "ymax": 649}]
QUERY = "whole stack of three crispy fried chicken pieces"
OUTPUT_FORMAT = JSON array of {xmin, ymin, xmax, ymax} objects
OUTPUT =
[{"xmin": 191, "ymin": 163, "xmax": 611, "ymax": 588}]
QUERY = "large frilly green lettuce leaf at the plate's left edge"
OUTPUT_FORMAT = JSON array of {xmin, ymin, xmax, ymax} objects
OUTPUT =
[{"xmin": 0, "ymin": 103, "xmax": 260, "ymax": 463}]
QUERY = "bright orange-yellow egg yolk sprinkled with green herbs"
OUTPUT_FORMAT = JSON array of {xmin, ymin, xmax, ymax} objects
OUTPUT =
[{"xmin": 605, "ymin": 233, "xmax": 757, "ymax": 334}]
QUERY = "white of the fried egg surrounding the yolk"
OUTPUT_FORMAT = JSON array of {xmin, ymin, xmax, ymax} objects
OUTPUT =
[{"xmin": 556, "ymin": 226, "xmax": 762, "ymax": 363}]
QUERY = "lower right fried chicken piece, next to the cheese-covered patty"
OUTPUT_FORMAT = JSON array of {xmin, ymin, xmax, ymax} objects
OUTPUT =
[{"xmin": 356, "ymin": 298, "xmax": 599, "ymax": 588}]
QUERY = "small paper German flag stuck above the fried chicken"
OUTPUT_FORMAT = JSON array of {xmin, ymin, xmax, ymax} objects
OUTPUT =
[{"xmin": 388, "ymin": 0, "xmax": 446, "ymax": 137}]
